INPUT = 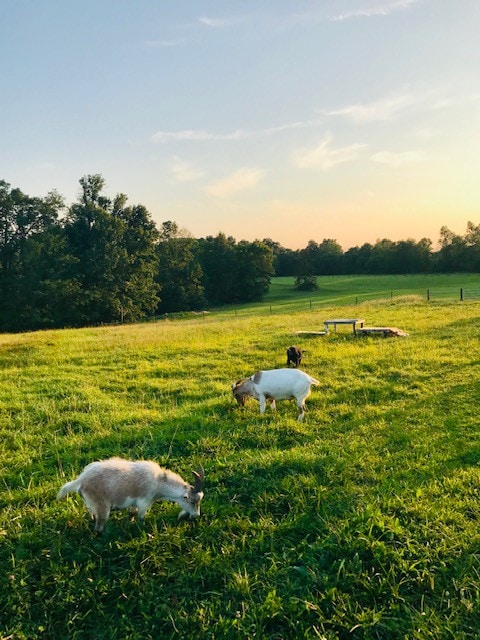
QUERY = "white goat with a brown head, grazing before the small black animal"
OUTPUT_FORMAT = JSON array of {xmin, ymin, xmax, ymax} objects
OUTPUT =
[{"xmin": 232, "ymin": 369, "xmax": 320, "ymax": 420}]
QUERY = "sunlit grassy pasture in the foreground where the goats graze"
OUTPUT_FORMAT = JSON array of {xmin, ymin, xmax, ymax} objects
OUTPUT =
[{"xmin": 0, "ymin": 277, "xmax": 480, "ymax": 640}]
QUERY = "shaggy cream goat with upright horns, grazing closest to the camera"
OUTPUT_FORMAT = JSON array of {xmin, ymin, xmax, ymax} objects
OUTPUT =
[{"xmin": 57, "ymin": 458, "xmax": 205, "ymax": 532}]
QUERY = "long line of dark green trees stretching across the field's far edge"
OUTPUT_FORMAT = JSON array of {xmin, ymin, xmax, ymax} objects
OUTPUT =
[{"xmin": 0, "ymin": 174, "xmax": 480, "ymax": 331}]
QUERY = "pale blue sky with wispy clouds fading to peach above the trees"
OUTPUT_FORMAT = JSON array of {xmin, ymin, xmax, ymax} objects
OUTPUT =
[{"xmin": 0, "ymin": 0, "xmax": 480, "ymax": 250}]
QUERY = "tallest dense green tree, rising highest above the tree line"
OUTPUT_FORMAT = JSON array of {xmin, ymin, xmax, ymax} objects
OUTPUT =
[{"xmin": 65, "ymin": 175, "xmax": 158, "ymax": 324}]
